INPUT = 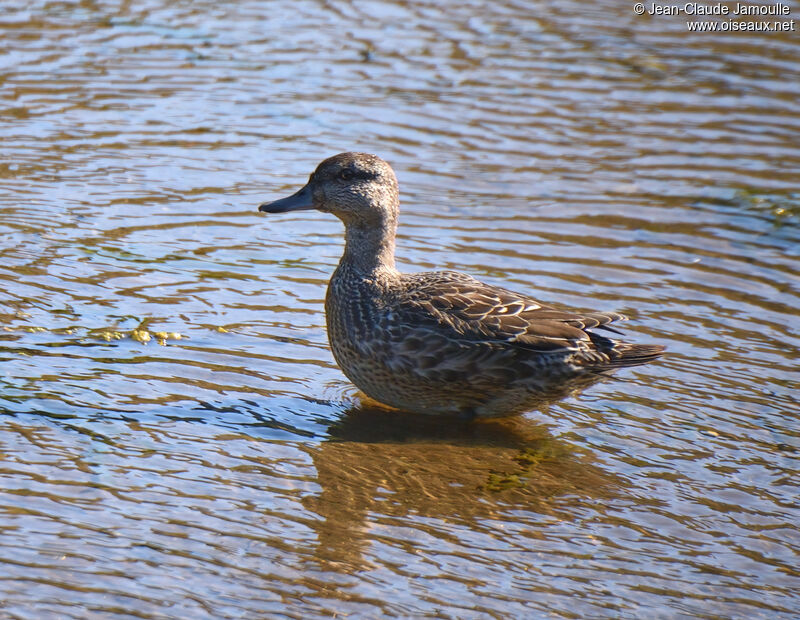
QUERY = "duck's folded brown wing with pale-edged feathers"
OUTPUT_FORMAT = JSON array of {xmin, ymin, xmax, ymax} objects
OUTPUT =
[{"xmin": 394, "ymin": 271, "xmax": 625, "ymax": 352}]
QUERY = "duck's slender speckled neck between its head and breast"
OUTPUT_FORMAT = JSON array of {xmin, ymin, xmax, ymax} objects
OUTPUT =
[{"xmin": 340, "ymin": 217, "xmax": 397, "ymax": 275}]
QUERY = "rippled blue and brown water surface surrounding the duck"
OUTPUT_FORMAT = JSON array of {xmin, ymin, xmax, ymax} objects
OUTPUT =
[{"xmin": 0, "ymin": 0, "xmax": 800, "ymax": 619}]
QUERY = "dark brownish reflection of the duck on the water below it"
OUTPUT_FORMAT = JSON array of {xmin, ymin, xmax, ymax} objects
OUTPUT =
[{"xmin": 304, "ymin": 382, "xmax": 621, "ymax": 570}]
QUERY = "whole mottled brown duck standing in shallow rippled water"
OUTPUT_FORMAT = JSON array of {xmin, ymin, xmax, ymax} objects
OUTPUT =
[{"xmin": 258, "ymin": 152, "xmax": 665, "ymax": 419}]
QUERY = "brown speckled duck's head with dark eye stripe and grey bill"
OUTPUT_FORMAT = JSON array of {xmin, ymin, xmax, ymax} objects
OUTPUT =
[{"xmin": 258, "ymin": 153, "xmax": 399, "ymax": 227}]
